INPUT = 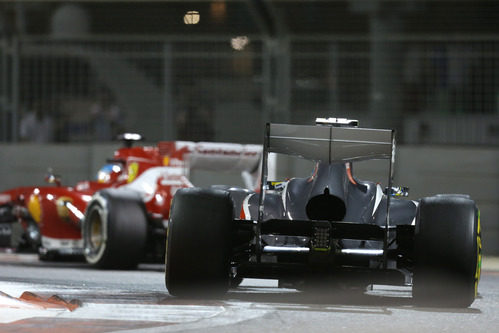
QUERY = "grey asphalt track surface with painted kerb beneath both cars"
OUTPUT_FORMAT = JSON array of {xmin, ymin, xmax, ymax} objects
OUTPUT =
[{"xmin": 0, "ymin": 254, "xmax": 499, "ymax": 333}]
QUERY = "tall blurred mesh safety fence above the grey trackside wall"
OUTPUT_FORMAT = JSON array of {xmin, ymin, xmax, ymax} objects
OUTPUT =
[{"xmin": 0, "ymin": 35, "xmax": 499, "ymax": 145}]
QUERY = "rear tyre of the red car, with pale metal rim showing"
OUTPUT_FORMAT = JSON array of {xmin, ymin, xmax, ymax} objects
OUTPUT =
[{"xmin": 82, "ymin": 189, "xmax": 147, "ymax": 269}]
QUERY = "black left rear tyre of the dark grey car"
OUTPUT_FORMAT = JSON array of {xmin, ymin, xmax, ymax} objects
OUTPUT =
[{"xmin": 165, "ymin": 188, "xmax": 234, "ymax": 297}]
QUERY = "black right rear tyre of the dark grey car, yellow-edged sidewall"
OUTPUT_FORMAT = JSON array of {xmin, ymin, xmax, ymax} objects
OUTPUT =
[{"xmin": 413, "ymin": 195, "xmax": 481, "ymax": 307}]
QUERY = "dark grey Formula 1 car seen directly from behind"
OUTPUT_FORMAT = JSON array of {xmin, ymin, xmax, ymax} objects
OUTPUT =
[{"xmin": 165, "ymin": 118, "xmax": 481, "ymax": 307}]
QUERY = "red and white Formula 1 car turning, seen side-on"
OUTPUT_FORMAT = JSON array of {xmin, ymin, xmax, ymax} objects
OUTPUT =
[{"xmin": 0, "ymin": 133, "xmax": 262, "ymax": 269}]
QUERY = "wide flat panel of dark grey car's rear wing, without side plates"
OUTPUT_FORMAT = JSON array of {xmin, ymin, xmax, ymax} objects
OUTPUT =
[{"xmin": 264, "ymin": 124, "xmax": 394, "ymax": 163}]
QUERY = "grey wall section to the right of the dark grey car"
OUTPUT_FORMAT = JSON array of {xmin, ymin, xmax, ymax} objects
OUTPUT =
[{"xmin": 395, "ymin": 146, "xmax": 499, "ymax": 255}]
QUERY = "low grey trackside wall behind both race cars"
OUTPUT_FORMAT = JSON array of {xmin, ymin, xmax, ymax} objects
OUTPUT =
[{"xmin": 0, "ymin": 144, "xmax": 499, "ymax": 255}]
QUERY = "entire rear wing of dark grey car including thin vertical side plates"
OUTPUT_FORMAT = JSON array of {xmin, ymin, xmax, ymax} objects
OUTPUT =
[{"xmin": 255, "ymin": 118, "xmax": 395, "ymax": 268}]
